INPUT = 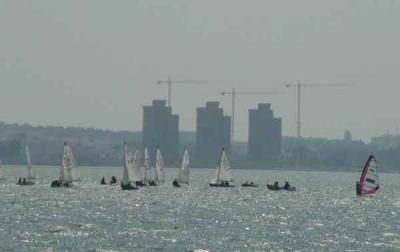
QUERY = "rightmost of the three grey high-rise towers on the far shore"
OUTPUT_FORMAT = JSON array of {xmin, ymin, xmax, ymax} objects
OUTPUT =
[{"xmin": 248, "ymin": 103, "xmax": 282, "ymax": 161}]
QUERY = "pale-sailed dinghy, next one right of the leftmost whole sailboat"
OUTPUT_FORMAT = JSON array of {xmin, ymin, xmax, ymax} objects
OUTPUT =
[{"xmin": 51, "ymin": 142, "xmax": 73, "ymax": 187}]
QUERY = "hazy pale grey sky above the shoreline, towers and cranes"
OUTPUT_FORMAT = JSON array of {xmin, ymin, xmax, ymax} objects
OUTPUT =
[{"xmin": 0, "ymin": 0, "xmax": 400, "ymax": 140}]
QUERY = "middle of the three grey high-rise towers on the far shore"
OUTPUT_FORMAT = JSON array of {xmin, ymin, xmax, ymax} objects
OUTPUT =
[{"xmin": 196, "ymin": 102, "xmax": 231, "ymax": 165}]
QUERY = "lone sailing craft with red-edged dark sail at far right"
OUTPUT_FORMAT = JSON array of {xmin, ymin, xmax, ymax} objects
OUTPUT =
[{"xmin": 356, "ymin": 155, "xmax": 379, "ymax": 197}]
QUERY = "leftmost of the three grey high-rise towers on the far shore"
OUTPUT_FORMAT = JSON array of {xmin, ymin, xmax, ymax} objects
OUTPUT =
[{"xmin": 143, "ymin": 100, "xmax": 179, "ymax": 164}]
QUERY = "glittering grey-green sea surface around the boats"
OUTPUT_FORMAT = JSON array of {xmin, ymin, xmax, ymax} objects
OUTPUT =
[{"xmin": 0, "ymin": 166, "xmax": 400, "ymax": 251}]
